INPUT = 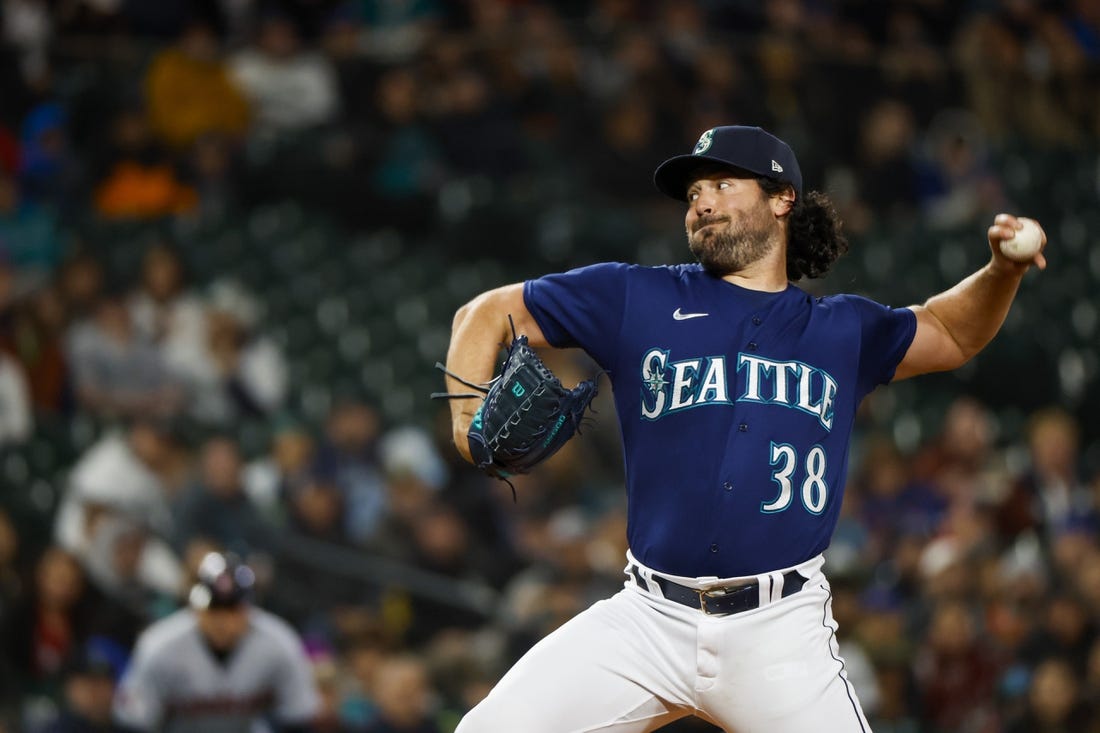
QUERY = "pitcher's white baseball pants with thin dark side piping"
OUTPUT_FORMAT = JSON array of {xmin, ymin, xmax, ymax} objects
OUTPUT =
[{"xmin": 455, "ymin": 556, "xmax": 871, "ymax": 733}]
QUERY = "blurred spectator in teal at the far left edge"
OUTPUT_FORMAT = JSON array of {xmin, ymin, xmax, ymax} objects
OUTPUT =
[{"xmin": 0, "ymin": 168, "xmax": 63, "ymax": 276}]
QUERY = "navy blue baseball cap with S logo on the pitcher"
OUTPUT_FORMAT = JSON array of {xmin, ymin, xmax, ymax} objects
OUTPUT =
[{"xmin": 653, "ymin": 124, "xmax": 802, "ymax": 201}]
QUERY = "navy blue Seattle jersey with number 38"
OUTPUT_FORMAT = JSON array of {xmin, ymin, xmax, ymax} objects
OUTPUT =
[{"xmin": 524, "ymin": 263, "xmax": 916, "ymax": 578}]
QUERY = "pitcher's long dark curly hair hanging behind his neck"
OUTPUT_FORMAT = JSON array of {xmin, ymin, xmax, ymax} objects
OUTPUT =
[{"xmin": 757, "ymin": 177, "xmax": 848, "ymax": 283}]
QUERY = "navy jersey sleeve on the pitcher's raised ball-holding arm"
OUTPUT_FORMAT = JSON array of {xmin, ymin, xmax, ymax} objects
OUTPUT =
[{"xmin": 842, "ymin": 295, "xmax": 916, "ymax": 396}]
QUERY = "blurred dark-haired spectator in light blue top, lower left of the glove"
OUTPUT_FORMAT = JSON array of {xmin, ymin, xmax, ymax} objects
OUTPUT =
[{"xmin": 315, "ymin": 402, "xmax": 386, "ymax": 543}]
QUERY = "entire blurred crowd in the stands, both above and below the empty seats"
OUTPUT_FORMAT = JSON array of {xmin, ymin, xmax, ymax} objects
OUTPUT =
[{"xmin": 0, "ymin": 0, "xmax": 1100, "ymax": 733}]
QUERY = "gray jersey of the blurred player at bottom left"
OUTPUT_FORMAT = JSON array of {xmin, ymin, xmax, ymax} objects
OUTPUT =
[{"xmin": 114, "ymin": 608, "xmax": 319, "ymax": 733}]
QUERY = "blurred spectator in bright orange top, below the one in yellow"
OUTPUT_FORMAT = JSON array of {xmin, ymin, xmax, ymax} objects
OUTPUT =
[{"xmin": 95, "ymin": 106, "xmax": 198, "ymax": 219}]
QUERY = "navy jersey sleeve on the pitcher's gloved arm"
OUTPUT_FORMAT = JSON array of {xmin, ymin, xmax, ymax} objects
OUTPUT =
[{"xmin": 524, "ymin": 263, "xmax": 630, "ymax": 370}]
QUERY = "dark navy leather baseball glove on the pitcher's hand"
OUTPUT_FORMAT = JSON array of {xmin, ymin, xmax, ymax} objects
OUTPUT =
[{"xmin": 431, "ymin": 318, "xmax": 598, "ymax": 479}]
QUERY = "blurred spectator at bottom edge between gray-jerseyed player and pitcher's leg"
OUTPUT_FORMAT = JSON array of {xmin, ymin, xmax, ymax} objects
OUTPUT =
[{"xmin": 364, "ymin": 655, "xmax": 442, "ymax": 733}]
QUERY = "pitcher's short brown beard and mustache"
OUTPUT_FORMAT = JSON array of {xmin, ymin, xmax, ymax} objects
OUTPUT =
[{"xmin": 688, "ymin": 206, "xmax": 777, "ymax": 277}]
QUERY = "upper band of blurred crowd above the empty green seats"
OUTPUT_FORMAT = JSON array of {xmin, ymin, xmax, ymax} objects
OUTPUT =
[{"xmin": 0, "ymin": 0, "xmax": 1100, "ymax": 236}]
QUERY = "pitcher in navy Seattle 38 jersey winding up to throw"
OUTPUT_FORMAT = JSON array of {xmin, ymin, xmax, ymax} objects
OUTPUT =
[{"xmin": 446, "ymin": 127, "xmax": 1046, "ymax": 733}]
